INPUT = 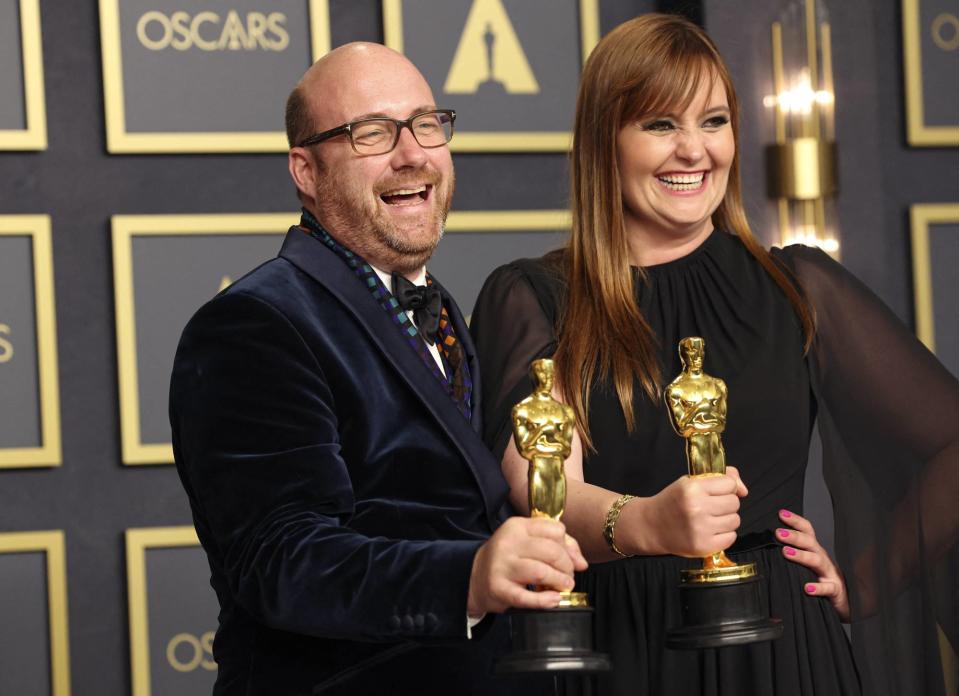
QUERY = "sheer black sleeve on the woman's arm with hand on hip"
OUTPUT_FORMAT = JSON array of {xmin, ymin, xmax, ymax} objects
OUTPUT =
[{"xmin": 776, "ymin": 247, "xmax": 959, "ymax": 695}]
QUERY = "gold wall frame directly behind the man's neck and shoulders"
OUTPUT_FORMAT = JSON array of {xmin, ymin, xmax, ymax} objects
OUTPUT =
[{"xmin": 111, "ymin": 210, "xmax": 571, "ymax": 465}]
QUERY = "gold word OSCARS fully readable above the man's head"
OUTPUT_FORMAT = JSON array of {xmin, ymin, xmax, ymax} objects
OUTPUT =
[{"xmin": 136, "ymin": 10, "xmax": 290, "ymax": 51}]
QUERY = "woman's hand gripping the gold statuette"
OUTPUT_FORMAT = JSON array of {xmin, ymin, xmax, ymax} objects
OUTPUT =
[{"xmin": 632, "ymin": 466, "xmax": 748, "ymax": 558}]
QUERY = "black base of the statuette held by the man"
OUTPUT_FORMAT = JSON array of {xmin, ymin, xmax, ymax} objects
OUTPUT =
[{"xmin": 493, "ymin": 607, "xmax": 610, "ymax": 675}]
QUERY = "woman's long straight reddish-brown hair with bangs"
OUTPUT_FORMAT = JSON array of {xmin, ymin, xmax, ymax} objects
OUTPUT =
[{"xmin": 555, "ymin": 13, "xmax": 815, "ymax": 449}]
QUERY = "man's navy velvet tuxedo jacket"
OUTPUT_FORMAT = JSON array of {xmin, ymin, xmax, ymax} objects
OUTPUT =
[{"xmin": 170, "ymin": 227, "xmax": 532, "ymax": 695}]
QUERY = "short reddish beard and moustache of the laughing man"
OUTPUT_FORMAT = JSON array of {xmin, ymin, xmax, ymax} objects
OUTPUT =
[{"xmin": 315, "ymin": 168, "xmax": 454, "ymax": 273}]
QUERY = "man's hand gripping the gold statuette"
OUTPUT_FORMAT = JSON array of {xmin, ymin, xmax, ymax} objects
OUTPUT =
[{"xmin": 466, "ymin": 517, "xmax": 586, "ymax": 617}]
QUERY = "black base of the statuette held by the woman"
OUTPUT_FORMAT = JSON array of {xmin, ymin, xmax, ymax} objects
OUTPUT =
[{"xmin": 666, "ymin": 575, "xmax": 783, "ymax": 650}]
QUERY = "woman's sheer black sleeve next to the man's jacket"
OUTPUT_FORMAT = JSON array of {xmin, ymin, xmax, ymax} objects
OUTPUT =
[{"xmin": 470, "ymin": 259, "xmax": 560, "ymax": 459}]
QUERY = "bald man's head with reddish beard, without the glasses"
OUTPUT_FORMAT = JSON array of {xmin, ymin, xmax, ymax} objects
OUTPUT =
[{"xmin": 287, "ymin": 43, "xmax": 454, "ymax": 277}]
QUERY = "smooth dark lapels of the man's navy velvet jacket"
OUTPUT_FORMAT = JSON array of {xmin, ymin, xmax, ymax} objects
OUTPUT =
[{"xmin": 279, "ymin": 227, "xmax": 506, "ymax": 527}]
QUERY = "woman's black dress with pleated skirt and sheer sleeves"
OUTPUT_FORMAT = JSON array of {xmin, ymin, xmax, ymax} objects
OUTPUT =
[{"xmin": 471, "ymin": 231, "xmax": 959, "ymax": 696}]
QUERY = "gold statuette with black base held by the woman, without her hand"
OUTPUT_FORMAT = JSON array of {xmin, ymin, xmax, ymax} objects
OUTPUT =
[{"xmin": 663, "ymin": 336, "xmax": 783, "ymax": 649}]
